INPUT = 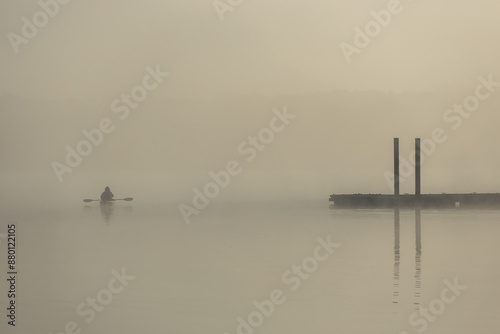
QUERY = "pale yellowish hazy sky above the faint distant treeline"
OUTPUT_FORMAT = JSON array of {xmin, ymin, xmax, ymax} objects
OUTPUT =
[{"xmin": 0, "ymin": 0, "xmax": 500, "ymax": 98}]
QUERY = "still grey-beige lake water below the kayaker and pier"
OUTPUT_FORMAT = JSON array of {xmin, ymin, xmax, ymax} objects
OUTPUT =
[{"xmin": 0, "ymin": 202, "xmax": 500, "ymax": 334}]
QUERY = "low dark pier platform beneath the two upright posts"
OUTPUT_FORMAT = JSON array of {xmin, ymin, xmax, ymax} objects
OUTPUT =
[{"xmin": 330, "ymin": 193, "xmax": 500, "ymax": 209}]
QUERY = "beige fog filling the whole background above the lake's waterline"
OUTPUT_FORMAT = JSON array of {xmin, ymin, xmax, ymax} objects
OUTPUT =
[{"xmin": 0, "ymin": 0, "xmax": 500, "ymax": 205}]
